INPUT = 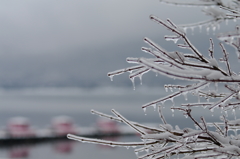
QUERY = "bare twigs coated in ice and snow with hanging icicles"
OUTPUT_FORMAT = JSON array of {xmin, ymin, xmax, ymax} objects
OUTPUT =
[{"xmin": 68, "ymin": 0, "xmax": 240, "ymax": 159}]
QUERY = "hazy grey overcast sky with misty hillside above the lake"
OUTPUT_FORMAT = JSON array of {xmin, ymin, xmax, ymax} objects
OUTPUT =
[{"xmin": 0, "ymin": 0, "xmax": 235, "ymax": 87}]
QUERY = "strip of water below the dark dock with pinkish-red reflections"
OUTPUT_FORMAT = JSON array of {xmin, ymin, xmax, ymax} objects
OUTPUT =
[{"xmin": 0, "ymin": 136, "xmax": 137, "ymax": 159}]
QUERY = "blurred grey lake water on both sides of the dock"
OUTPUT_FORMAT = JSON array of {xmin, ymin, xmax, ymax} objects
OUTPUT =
[{"xmin": 0, "ymin": 87, "xmax": 234, "ymax": 159}]
